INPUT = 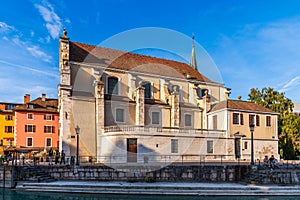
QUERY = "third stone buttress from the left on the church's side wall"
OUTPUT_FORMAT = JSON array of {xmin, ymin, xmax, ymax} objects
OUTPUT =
[{"xmin": 170, "ymin": 86, "xmax": 180, "ymax": 128}]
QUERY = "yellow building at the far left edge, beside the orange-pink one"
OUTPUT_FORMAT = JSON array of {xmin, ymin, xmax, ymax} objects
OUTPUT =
[{"xmin": 0, "ymin": 102, "xmax": 18, "ymax": 150}]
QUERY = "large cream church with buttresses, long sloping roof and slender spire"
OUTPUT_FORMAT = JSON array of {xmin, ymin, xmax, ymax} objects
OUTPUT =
[{"xmin": 58, "ymin": 31, "xmax": 277, "ymax": 163}]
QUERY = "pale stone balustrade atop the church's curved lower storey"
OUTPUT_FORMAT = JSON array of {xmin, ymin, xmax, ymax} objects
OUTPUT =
[{"xmin": 104, "ymin": 125, "xmax": 226, "ymax": 136}]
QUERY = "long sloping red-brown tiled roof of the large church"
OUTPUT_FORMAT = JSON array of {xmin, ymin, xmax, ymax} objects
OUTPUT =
[{"xmin": 70, "ymin": 42, "xmax": 213, "ymax": 83}]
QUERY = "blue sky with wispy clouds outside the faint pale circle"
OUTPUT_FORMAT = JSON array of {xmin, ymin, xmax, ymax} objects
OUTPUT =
[{"xmin": 0, "ymin": 0, "xmax": 300, "ymax": 102}]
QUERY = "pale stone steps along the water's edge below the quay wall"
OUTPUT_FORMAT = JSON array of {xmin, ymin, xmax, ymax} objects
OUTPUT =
[{"xmin": 16, "ymin": 181, "xmax": 300, "ymax": 196}]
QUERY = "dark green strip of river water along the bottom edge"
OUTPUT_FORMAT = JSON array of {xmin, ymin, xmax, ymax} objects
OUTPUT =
[{"xmin": 1, "ymin": 189, "xmax": 300, "ymax": 200}]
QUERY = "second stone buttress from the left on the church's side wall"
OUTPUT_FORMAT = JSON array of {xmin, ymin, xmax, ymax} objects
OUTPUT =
[{"xmin": 135, "ymin": 83, "xmax": 145, "ymax": 126}]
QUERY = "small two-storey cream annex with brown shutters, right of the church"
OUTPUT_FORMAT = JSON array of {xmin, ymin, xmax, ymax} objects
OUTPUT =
[{"xmin": 208, "ymin": 100, "xmax": 279, "ymax": 161}]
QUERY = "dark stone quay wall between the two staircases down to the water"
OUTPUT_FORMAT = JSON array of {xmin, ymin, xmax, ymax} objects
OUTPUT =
[{"xmin": 15, "ymin": 166, "xmax": 248, "ymax": 182}]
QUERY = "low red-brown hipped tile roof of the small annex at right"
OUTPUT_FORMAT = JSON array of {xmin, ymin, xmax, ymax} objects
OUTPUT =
[{"xmin": 209, "ymin": 100, "xmax": 276, "ymax": 114}]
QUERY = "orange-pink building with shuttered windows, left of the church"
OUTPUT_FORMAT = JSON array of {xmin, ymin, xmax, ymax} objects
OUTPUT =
[{"xmin": 14, "ymin": 94, "xmax": 59, "ymax": 149}]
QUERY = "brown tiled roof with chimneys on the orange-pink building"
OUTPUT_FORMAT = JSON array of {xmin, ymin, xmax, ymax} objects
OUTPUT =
[{"xmin": 14, "ymin": 97, "xmax": 58, "ymax": 113}]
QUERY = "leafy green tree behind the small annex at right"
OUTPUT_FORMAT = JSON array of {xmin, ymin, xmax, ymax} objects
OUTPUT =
[{"xmin": 248, "ymin": 87, "xmax": 300, "ymax": 159}]
